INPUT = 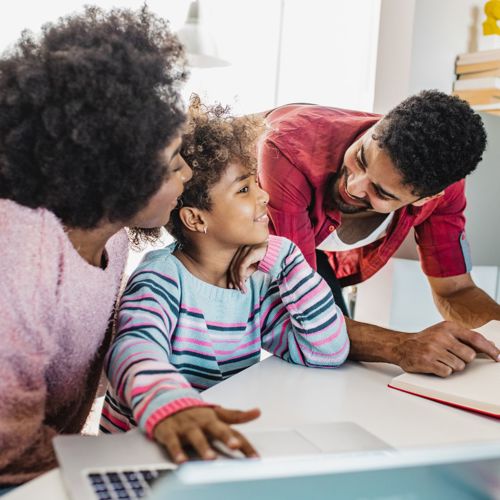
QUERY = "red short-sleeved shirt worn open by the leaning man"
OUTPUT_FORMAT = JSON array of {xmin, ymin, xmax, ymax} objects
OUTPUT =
[{"xmin": 259, "ymin": 104, "xmax": 471, "ymax": 286}]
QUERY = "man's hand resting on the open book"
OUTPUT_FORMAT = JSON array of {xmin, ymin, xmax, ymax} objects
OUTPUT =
[{"xmin": 395, "ymin": 321, "xmax": 500, "ymax": 377}]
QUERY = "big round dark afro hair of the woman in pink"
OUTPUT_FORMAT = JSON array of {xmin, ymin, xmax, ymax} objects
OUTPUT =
[{"xmin": 0, "ymin": 7, "xmax": 186, "ymax": 229}]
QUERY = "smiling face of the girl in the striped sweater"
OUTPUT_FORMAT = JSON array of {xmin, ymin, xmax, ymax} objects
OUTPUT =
[{"xmin": 204, "ymin": 163, "xmax": 269, "ymax": 248}]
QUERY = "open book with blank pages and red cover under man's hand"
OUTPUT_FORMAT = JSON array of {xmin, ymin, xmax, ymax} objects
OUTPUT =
[{"xmin": 389, "ymin": 321, "xmax": 500, "ymax": 418}]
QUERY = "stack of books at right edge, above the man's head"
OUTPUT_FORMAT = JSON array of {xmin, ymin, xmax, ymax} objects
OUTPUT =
[{"xmin": 453, "ymin": 49, "xmax": 500, "ymax": 114}]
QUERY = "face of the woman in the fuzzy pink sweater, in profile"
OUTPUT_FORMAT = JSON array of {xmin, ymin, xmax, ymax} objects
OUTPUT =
[{"xmin": 128, "ymin": 135, "xmax": 193, "ymax": 229}]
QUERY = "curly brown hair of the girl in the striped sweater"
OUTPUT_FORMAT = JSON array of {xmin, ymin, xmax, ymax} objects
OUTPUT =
[{"xmin": 166, "ymin": 95, "xmax": 264, "ymax": 245}]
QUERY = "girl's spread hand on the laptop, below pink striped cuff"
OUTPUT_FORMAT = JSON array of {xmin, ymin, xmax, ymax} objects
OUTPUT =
[{"xmin": 154, "ymin": 406, "xmax": 260, "ymax": 463}]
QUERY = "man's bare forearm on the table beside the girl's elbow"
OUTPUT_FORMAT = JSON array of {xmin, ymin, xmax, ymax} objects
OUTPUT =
[{"xmin": 346, "ymin": 318, "xmax": 408, "ymax": 365}]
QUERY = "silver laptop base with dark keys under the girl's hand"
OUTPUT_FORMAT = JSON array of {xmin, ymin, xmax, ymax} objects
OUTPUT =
[{"xmin": 54, "ymin": 422, "xmax": 393, "ymax": 500}]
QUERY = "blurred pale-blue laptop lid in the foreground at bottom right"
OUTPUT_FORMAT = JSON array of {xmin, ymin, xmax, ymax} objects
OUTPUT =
[{"xmin": 150, "ymin": 442, "xmax": 500, "ymax": 500}]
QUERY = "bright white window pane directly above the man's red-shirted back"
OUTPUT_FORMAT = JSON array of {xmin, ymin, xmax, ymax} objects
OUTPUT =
[{"xmin": 278, "ymin": 0, "xmax": 380, "ymax": 110}]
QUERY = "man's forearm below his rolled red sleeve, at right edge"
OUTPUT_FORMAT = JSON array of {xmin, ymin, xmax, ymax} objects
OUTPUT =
[{"xmin": 433, "ymin": 286, "xmax": 500, "ymax": 328}]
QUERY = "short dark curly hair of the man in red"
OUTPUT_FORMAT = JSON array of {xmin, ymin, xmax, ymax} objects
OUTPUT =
[{"xmin": 373, "ymin": 90, "xmax": 486, "ymax": 198}]
